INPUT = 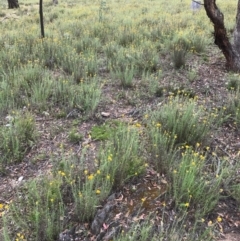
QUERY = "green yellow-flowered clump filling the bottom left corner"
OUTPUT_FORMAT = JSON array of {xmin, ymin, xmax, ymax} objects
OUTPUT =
[{"xmin": 4, "ymin": 175, "xmax": 64, "ymax": 241}]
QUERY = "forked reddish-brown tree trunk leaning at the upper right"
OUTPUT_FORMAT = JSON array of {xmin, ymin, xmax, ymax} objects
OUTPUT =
[{"xmin": 204, "ymin": 0, "xmax": 240, "ymax": 72}]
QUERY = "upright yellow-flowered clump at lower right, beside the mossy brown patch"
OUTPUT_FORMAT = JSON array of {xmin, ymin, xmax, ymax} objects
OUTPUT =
[{"xmin": 170, "ymin": 146, "xmax": 221, "ymax": 216}]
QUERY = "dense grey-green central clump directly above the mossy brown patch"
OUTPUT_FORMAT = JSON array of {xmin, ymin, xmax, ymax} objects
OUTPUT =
[{"xmin": 100, "ymin": 124, "xmax": 145, "ymax": 188}]
